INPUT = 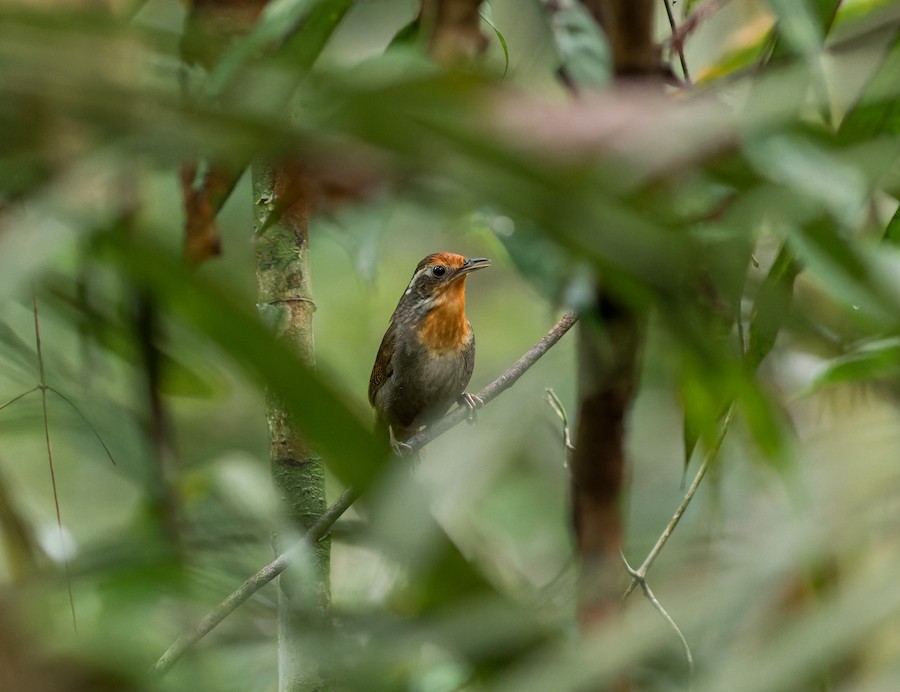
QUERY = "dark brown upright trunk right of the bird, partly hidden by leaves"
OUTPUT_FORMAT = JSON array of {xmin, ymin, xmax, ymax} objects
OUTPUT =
[{"xmin": 572, "ymin": 0, "xmax": 661, "ymax": 627}]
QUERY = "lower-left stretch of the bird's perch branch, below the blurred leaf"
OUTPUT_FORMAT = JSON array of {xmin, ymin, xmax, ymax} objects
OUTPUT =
[{"xmin": 151, "ymin": 488, "xmax": 356, "ymax": 675}]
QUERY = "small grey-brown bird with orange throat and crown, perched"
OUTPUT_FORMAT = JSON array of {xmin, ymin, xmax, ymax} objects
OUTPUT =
[{"xmin": 369, "ymin": 252, "xmax": 491, "ymax": 451}]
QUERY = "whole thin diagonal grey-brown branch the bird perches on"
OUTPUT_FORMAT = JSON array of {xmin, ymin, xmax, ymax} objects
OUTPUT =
[{"xmin": 152, "ymin": 312, "xmax": 578, "ymax": 675}]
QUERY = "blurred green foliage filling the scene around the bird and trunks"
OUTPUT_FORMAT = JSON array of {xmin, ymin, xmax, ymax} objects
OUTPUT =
[{"xmin": 0, "ymin": 0, "xmax": 900, "ymax": 692}]
